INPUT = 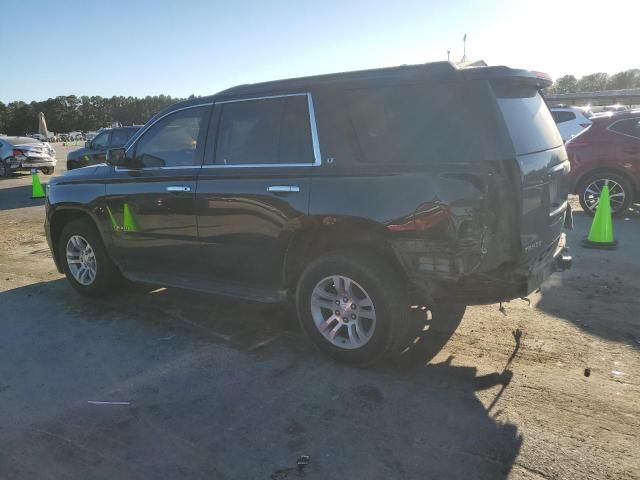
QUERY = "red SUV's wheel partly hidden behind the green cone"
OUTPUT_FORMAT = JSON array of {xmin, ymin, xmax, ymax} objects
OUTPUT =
[{"xmin": 577, "ymin": 171, "xmax": 633, "ymax": 217}]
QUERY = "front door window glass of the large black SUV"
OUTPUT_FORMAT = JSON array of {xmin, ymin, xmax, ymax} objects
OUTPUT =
[{"xmin": 135, "ymin": 107, "xmax": 207, "ymax": 167}]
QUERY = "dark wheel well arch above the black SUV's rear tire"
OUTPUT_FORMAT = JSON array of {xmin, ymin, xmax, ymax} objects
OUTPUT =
[{"xmin": 283, "ymin": 222, "xmax": 405, "ymax": 289}]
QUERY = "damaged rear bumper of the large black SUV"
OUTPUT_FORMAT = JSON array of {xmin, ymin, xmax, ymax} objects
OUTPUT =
[{"xmin": 410, "ymin": 233, "xmax": 572, "ymax": 305}]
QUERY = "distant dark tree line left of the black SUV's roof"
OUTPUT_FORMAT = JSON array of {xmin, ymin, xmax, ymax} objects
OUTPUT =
[{"xmin": 0, "ymin": 95, "xmax": 193, "ymax": 135}]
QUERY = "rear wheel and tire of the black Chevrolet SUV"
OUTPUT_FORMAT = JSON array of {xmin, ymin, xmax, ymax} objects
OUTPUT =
[{"xmin": 296, "ymin": 249, "xmax": 409, "ymax": 366}]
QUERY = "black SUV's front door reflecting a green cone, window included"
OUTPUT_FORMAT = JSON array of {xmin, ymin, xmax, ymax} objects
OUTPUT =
[{"xmin": 106, "ymin": 106, "xmax": 210, "ymax": 280}]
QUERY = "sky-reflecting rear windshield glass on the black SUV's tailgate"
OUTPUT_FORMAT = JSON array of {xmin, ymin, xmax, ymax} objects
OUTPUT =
[{"xmin": 493, "ymin": 83, "xmax": 562, "ymax": 155}]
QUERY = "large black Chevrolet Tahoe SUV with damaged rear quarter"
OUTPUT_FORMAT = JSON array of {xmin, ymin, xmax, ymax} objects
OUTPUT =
[{"xmin": 45, "ymin": 63, "xmax": 571, "ymax": 364}]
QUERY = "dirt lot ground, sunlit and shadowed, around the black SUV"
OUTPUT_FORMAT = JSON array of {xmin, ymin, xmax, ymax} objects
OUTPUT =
[{"xmin": 0, "ymin": 144, "xmax": 640, "ymax": 480}]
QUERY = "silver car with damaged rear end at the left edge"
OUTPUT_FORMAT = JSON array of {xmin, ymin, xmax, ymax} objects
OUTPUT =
[{"xmin": 0, "ymin": 136, "xmax": 57, "ymax": 177}]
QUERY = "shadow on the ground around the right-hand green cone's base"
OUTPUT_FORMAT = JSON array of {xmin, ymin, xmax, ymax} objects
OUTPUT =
[{"xmin": 536, "ymin": 209, "xmax": 640, "ymax": 348}]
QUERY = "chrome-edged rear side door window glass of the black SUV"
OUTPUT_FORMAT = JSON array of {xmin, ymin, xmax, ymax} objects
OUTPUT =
[{"xmin": 216, "ymin": 95, "xmax": 313, "ymax": 165}]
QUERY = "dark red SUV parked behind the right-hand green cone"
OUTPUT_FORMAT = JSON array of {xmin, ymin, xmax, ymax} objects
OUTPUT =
[{"xmin": 565, "ymin": 110, "xmax": 640, "ymax": 215}]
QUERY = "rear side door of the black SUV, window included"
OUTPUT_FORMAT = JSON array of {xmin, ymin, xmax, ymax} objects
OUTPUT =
[{"xmin": 196, "ymin": 93, "xmax": 320, "ymax": 287}]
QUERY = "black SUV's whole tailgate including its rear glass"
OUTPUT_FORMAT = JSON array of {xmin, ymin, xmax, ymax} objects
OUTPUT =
[{"xmin": 493, "ymin": 80, "xmax": 570, "ymax": 262}]
